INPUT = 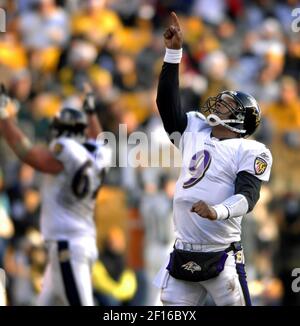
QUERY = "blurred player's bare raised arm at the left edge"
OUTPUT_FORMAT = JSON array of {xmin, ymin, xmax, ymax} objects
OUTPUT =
[{"xmin": 0, "ymin": 89, "xmax": 64, "ymax": 174}]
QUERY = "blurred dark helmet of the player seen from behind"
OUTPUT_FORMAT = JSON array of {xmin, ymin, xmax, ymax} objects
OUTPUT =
[{"xmin": 50, "ymin": 108, "xmax": 87, "ymax": 139}]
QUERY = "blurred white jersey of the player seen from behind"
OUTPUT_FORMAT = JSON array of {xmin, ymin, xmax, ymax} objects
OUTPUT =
[{"xmin": 41, "ymin": 137, "xmax": 110, "ymax": 244}]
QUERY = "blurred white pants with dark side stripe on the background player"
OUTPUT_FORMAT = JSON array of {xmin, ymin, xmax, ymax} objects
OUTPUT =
[{"xmin": 38, "ymin": 241, "xmax": 97, "ymax": 306}]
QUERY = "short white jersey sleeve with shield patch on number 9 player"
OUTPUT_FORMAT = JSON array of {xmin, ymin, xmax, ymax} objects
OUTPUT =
[{"xmin": 237, "ymin": 142, "xmax": 273, "ymax": 181}]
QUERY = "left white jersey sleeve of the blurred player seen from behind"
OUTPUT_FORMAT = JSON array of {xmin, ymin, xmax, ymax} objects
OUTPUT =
[{"xmin": 50, "ymin": 138, "xmax": 83, "ymax": 173}]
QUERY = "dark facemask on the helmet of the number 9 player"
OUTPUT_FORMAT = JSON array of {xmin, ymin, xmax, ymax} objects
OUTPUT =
[{"xmin": 201, "ymin": 92, "xmax": 246, "ymax": 136}]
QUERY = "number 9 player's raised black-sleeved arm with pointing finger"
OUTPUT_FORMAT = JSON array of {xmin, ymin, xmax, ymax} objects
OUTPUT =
[{"xmin": 156, "ymin": 12, "xmax": 187, "ymax": 134}]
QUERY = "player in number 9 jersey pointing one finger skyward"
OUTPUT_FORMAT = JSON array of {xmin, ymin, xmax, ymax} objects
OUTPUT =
[{"xmin": 154, "ymin": 12, "xmax": 272, "ymax": 306}]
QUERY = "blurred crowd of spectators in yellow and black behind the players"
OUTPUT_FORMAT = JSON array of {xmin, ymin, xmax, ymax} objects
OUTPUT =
[{"xmin": 0, "ymin": 0, "xmax": 300, "ymax": 305}]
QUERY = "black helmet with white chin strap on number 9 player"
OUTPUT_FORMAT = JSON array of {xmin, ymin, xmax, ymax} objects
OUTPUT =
[{"xmin": 201, "ymin": 91, "xmax": 261, "ymax": 137}]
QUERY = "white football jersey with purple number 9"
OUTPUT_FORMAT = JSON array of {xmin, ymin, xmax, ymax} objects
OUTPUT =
[{"xmin": 173, "ymin": 112, "xmax": 272, "ymax": 245}]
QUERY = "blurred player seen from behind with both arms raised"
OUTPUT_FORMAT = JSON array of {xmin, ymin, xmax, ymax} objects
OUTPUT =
[{"xmin": 0, "ymin": 84, "xmax": 110, "ymax": 306}]
